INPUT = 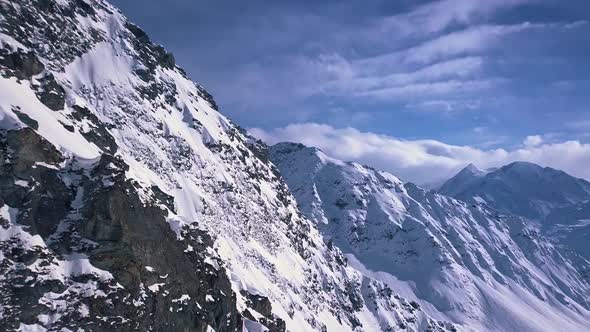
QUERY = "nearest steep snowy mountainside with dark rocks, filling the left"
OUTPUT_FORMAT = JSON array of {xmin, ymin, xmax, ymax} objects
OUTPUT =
[{"xmin": 0, "ymin": 0, "xmax": 462, "ymax": 331}]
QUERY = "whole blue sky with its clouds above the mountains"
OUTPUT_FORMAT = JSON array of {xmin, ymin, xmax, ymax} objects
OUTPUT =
[{"xmin": 113, "ymin": 0, "xmax": 590, "ymax": 183}]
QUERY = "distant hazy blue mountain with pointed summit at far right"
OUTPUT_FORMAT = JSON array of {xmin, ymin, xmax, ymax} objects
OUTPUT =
[{"xmin": 439, "ymin": 162, "xmax": 590, "ymax": 260}]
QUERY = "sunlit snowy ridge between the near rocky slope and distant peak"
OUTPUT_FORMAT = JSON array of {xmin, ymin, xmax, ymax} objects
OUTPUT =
[{"xmin": 270, "ymin": 143, "xmax": 590, "ymax": 331}]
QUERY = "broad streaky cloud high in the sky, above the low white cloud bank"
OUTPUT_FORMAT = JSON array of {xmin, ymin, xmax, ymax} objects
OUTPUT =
[{"xmin": 211, "ymin": 0, "xmax": 586, "ymax": 122}]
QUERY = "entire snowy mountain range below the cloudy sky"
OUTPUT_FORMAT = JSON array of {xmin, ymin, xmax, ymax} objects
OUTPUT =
[{"xmin": 0, "ymin": 0, "xmax": 590, "ymax": 332}]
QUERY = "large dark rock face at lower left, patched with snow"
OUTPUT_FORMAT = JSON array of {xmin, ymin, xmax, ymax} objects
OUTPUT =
[{"xmin": 0, "ymin": 128, "xmax": 274, "ymax": 331}]
